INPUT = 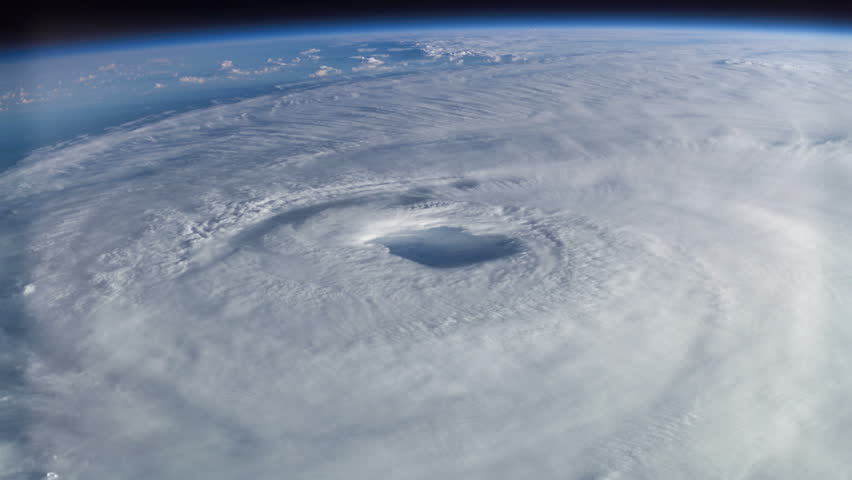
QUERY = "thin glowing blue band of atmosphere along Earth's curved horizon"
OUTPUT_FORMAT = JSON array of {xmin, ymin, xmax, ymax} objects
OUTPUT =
[{"xmin": 5, "ymin": 11, "xmax": 852, "ymax": 58}]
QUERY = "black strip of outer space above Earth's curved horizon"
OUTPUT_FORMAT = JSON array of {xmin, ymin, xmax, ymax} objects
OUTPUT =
[{"xmin": 5, "ymin": 0, "xmax": 852, "ymax": 49}]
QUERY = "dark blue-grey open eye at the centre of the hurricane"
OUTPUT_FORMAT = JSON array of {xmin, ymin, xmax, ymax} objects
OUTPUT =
[{"xmin": 373, "ymin": 227, "xmax": 521, "ymax": 268}]
